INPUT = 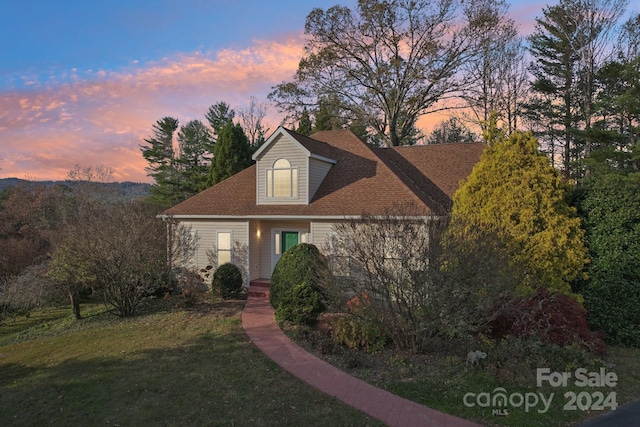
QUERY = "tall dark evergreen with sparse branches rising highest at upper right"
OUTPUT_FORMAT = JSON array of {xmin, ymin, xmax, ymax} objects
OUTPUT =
[{"xmin": 525, "ymin": 0, "xmax": 626, "ymax": 178}]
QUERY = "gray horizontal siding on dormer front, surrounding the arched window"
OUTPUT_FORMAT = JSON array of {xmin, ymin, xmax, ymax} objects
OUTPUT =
[{"xmin": 256, "ymin": 135, "xmax": 309, "ymax": 205}]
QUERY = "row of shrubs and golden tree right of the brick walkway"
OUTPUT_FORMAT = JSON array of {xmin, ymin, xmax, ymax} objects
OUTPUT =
[{"xmin": 271, "ymin": 129, "xmax": 640, "ymax": 378}]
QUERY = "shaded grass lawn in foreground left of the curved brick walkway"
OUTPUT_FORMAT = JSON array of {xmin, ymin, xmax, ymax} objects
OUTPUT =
[{"xmin": 0, "ymin": 302, "xmax": 378, "ymax": 426}]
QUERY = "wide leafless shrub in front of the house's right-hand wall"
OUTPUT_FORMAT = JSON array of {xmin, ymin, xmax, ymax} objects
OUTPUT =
[{"xmin": 323, "ymin": 204, "xmax": 522, "ymax": 351}]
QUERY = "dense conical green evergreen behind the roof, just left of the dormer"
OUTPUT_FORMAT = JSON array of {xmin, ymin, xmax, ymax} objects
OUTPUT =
[{"xmin": 208, "ymin": 121, "xmax": 253, "ymax": 185}]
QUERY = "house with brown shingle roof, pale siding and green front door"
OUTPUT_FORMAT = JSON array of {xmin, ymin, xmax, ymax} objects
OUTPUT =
[{"xmin": 164, "ymin": 127, "xmax": 485, "ymax": 288}]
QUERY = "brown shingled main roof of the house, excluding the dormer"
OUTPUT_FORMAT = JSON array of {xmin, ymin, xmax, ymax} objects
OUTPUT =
[{"xmin": 165, "ymin": 128, "xmax": 485, "ymax": 218}]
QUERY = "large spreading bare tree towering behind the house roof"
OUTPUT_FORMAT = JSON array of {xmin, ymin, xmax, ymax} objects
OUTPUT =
[{"xmin": 269, "ymin": 0, "xmax": 493, "ymax": 146}]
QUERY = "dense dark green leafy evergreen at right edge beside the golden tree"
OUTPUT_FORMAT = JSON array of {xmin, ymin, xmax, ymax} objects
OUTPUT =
[{"xmin": 577, "ymin": 173, "xmax": 640, "ymax": 347}]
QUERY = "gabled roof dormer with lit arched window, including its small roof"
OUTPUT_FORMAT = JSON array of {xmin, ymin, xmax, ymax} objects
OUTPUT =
[{"xmin": 253, "ymin": 126, "xmax": 336, "ymax": 205}]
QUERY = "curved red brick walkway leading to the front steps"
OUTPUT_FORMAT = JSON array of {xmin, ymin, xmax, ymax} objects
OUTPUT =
[{"xmin": 242, "ymin": 296, "xmax": 478, "ymax": 427}]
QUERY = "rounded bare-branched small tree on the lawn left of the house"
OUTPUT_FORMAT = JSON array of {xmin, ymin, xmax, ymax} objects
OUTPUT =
[{"xmin": 53, "ymin": 201, "xmax": 169, "ymax": 317}]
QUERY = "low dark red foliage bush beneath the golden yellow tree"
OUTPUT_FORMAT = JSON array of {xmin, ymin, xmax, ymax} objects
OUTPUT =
[{"xmin": 489, "ymin": 288, "xmax": 607, "ymax": 356}]
